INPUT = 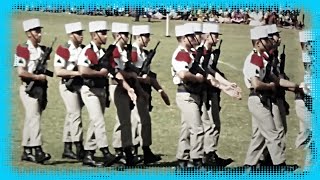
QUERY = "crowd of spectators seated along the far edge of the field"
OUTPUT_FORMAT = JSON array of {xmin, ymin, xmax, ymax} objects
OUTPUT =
[{"xmin": 15, "ymin": 4, "xmax": 304, "ymax": 29}]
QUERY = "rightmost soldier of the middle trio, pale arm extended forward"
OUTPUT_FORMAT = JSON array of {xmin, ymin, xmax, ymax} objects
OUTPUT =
[{"xmin": 199, "ymin": 23, "xmax": 241, "ymax": 166}]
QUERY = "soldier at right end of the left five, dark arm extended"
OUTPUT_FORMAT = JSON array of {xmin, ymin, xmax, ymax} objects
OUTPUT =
[{"xmin": 131, "ymin": 25, "xmax": 170, "ymax": 164}]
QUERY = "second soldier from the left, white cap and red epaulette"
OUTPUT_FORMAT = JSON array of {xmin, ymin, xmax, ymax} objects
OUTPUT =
[{"xmin": 54, "ymin": 22, "xmax": 84, "ymax": 160}]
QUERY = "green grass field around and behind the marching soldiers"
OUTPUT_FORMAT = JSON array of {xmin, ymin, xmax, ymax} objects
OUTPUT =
[{"xmin": 9, "ymin": 12, "xmax": 304, "ymax": 171}]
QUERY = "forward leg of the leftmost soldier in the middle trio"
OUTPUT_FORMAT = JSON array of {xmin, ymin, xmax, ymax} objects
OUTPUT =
[{"xmin": 176, "ymin": 93, "xmax": 204, "ymax": 166}]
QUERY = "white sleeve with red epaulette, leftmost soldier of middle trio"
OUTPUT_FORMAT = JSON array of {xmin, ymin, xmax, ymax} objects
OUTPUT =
[{"xmin": 172, "ymin": 52, "xmax": 192, "ymax": 73}]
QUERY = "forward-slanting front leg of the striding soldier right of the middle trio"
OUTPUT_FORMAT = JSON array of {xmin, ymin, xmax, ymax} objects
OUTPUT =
[{"xmin": 248, "ymin": 96, "xmax": 285, "ymax": 165}]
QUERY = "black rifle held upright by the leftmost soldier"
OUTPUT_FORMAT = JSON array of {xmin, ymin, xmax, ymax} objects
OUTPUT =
[{"xmin": 25, "ymin": 37, "xmax": 57, "ymax": 95}]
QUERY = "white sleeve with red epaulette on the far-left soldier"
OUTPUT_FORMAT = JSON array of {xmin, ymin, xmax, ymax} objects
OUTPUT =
[{"xmin": 13, "ymin": 44, "xmax": 30, "ymax": 67}]
